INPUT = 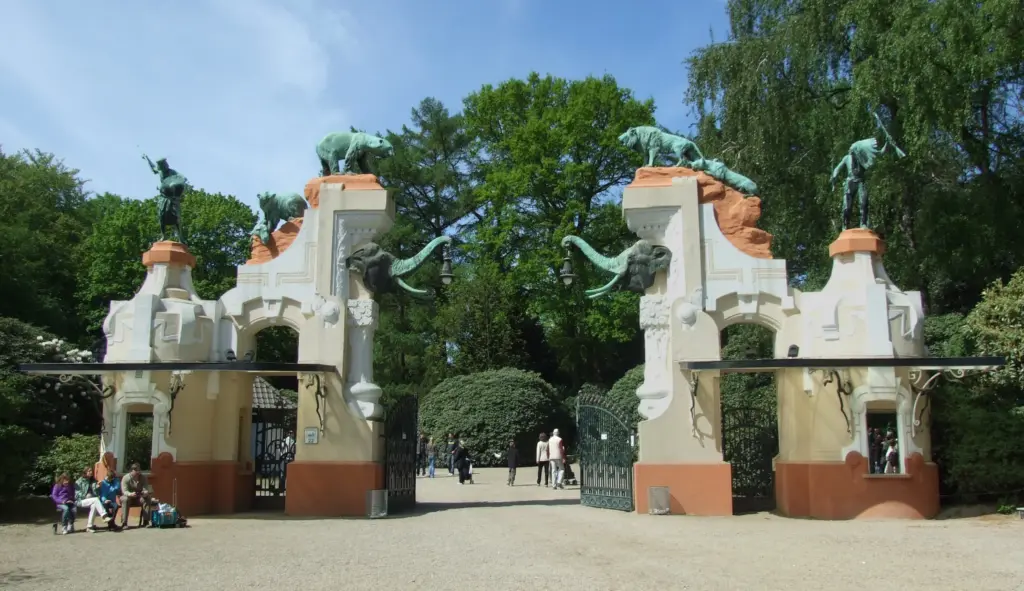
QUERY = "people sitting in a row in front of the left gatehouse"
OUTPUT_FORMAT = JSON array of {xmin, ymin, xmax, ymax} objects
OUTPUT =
[{"xmin": 50, "ymin": 464, "xmax": 153, "ymax": 535}]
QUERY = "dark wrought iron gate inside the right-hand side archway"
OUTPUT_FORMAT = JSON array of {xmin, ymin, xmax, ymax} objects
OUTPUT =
[{"xmin": 722, "ymin": 408, "xmax": 778, "ymax": 513}]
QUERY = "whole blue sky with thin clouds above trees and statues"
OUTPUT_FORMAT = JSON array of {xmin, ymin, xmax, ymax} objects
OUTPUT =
[{"xmin": 0, "ymin": 0, "xmax": 728, "ymax": 210}]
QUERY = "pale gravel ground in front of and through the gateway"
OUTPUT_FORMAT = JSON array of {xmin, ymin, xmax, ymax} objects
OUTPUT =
[{"xmin": 0, "ymin": 468, "xmax": 1024, "ymax": 591}]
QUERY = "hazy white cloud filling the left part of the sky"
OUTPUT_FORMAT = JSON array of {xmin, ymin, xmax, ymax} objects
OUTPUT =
[{"xmin": 0, "ymin": 0, "xmax": 360, "ymax": 204}]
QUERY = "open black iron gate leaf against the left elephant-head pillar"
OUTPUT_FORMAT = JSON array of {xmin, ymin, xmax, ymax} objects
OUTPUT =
[{"xmin": 384, "ymin": 396, "xmax": 420, "ymax": 513}]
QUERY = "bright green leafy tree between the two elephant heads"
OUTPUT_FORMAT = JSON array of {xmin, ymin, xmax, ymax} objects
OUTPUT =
[{"xmin": 464, "ymin": 73, "xmax": 654, "ymax": 391}]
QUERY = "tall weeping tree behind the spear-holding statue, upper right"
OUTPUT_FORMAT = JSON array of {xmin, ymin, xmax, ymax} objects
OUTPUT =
[{"xmin": 686, "ymin": 0, "xmax": 1024, "ymax": 313}]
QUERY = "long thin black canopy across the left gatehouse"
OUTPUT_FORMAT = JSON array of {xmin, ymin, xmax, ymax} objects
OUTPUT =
[{"xmin": 17, "ymin": 362, "xmax": 338, "ymax": 376}]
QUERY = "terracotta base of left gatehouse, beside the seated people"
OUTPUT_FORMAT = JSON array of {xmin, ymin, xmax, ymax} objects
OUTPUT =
[{"xmin": 150, "ymin": 453, "xmax": 253, "ymax": 516}]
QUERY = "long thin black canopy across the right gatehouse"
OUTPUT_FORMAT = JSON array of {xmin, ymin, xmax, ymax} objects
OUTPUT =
[{"xmin": 678, "ymin": 356, "xmax": 1007, "ymax": 374}]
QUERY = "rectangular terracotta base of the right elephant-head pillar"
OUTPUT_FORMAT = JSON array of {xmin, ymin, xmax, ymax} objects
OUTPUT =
[{"xmin": 633, "ymin": 462, "xmax": 732, "ymax": 515}]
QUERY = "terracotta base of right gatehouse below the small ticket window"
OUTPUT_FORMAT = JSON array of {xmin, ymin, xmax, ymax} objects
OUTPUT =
[{"xmin": 775, "ymin": 452, "xmax": 939, "ymax": 519}]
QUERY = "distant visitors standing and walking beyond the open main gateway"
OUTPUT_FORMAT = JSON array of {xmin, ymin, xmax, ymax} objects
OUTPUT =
[{"xmin": 416, "ymin": 429, "xmax": 566, "ymax": 489}]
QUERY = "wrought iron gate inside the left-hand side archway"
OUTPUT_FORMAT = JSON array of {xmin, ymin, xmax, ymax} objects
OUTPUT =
[{"xmin": 252, "ymin": 407, "xmax": 297, "ymax": 511}]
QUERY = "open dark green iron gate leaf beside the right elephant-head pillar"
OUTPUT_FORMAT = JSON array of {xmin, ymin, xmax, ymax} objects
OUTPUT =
[{"xmin": 577, "ymin": 394, "xmax": 635, "ymax": 511}]
